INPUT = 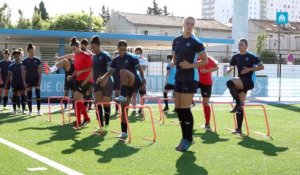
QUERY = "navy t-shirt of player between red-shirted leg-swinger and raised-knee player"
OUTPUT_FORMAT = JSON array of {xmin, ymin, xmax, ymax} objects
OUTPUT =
[{"xmin": 93, "ymin": 51, "xmax": 112, "ymax": 82}]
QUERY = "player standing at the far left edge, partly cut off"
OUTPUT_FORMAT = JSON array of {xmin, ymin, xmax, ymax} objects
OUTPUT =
[{"xmin": 0, "ymin": 49, "xmax": 12, "ymax": 111}]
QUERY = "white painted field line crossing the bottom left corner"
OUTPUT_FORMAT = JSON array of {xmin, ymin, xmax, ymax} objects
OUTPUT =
[{"xmin": 0, "ymin": 138, "xmax": 83, "ymax": 175}]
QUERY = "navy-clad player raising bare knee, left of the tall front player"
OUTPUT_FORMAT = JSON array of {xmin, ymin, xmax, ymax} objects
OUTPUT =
[{"xmin": 96, "ymin": 40, "xmax": 145, "ymax": 139}]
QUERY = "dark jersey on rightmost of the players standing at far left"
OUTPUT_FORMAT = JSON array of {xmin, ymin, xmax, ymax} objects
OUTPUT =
[{"xmin": 22, "ymin": 57, "xmax": 41, "ymax": 82}]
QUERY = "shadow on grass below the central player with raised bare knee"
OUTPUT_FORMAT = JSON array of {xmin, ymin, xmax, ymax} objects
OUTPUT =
[{"xmin": 94, "ymin": 141, "xmax": 140, "ymax": 163}]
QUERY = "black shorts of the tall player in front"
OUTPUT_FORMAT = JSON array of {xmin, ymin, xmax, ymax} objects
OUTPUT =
[{"xmin": 174, "ymin": 80, "xmax": 198, "ymax": 94}]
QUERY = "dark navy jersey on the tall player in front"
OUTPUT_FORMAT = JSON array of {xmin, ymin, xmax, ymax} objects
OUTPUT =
[{"xmin": 172, "ymin": 35, "xmax": 205, "ymax": 81}]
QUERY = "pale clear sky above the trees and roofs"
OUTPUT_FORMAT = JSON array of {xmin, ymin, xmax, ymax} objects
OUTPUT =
[{"xmin": 0, "ymin": 0, "xmax": 202, "ymax": 22}]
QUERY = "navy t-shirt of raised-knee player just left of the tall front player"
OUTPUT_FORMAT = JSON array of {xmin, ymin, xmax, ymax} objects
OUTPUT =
[{"xmin": 110, "ymin": 52, "xmax": 140, "ymax": 76}]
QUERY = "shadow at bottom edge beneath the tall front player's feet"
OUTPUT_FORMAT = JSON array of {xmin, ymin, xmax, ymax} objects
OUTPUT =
[{"xmin": 176, "ymin": 151, "xmax": 208, "ymax": 175}]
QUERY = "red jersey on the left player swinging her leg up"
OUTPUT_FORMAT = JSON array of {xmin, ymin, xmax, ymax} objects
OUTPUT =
[{"xmin": 74, "ymin": 52, "xmax": 93, "ymax": 81}]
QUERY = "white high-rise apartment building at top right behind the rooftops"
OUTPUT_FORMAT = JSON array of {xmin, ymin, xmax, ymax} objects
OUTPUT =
[{"xmin": 202, "ymin": 0, "xmax": 300, "ymax": 23}]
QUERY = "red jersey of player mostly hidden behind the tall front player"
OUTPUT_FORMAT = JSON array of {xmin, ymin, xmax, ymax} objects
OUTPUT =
[{"xmin": 198, "ymin": 57, "xmax": 217, "ymax": 85}]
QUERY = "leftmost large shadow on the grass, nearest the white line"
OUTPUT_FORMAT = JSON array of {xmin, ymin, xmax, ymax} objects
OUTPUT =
[{"xmin": 19, "ymin": 124, "xmax": 79, "ymax": 145}]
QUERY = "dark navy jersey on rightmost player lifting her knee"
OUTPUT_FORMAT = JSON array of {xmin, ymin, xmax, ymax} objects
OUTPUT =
[{"xmin": 230, "ymin": 51, "xmax": 261, "ymax": 81}]
